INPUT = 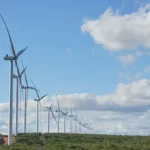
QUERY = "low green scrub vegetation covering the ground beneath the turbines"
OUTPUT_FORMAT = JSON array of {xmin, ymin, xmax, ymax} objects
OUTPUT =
[{"xmin": 0, "ymin": 133, "xmax": 150, "ymax": 150}]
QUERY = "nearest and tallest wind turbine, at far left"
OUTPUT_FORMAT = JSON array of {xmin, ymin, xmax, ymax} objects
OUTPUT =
[{"xmin": 0, "ymin": 14, "xmax": 27, "ymax": 145}]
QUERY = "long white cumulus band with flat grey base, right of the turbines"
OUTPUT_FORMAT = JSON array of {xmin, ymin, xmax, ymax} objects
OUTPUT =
[{"xmin": 46, "ymin": 79, "xmax": 150, "ymax": 112}]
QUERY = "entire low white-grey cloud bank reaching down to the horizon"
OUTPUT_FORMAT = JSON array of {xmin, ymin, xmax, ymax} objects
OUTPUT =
[{"xmin": 0, "ymin": 79, "xmax": 150, "ymax": 134}]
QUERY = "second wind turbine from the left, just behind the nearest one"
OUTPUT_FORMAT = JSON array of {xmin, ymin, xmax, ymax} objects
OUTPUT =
[{"xmin": 12, "ymin": 68, "xmax": 26, "ymax": 135}]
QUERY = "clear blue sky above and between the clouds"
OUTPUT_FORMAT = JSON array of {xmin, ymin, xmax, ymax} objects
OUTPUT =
[{"xmin": 0, "ymin": 0, "xmax": 148, "ymax": 101}]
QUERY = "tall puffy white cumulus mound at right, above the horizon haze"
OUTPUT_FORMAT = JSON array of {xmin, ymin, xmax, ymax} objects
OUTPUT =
[{"xmin": 97, "ymin": 79, "xmax": 150, "ymax": 111}]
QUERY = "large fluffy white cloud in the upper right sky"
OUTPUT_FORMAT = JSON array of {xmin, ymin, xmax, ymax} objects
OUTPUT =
[{"xmin": 81, "ymin": 4, "xmax": 150, "ymax": 51}]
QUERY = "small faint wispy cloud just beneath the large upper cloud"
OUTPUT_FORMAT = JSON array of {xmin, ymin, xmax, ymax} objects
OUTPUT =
[{"xmin": 116, "ymin": 54, "xmax": 135, "ymax": 66}]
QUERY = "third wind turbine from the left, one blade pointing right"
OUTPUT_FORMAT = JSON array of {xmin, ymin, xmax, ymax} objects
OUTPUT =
[{"xmin": 21, "ymin": 61, "xmax": 38, "ymax": 133}]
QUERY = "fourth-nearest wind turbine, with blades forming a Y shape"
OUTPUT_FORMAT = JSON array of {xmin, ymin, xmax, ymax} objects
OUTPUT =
[{"xmin": 32, "ymin": 81, "xmax": 47, "ymax": 133}]
